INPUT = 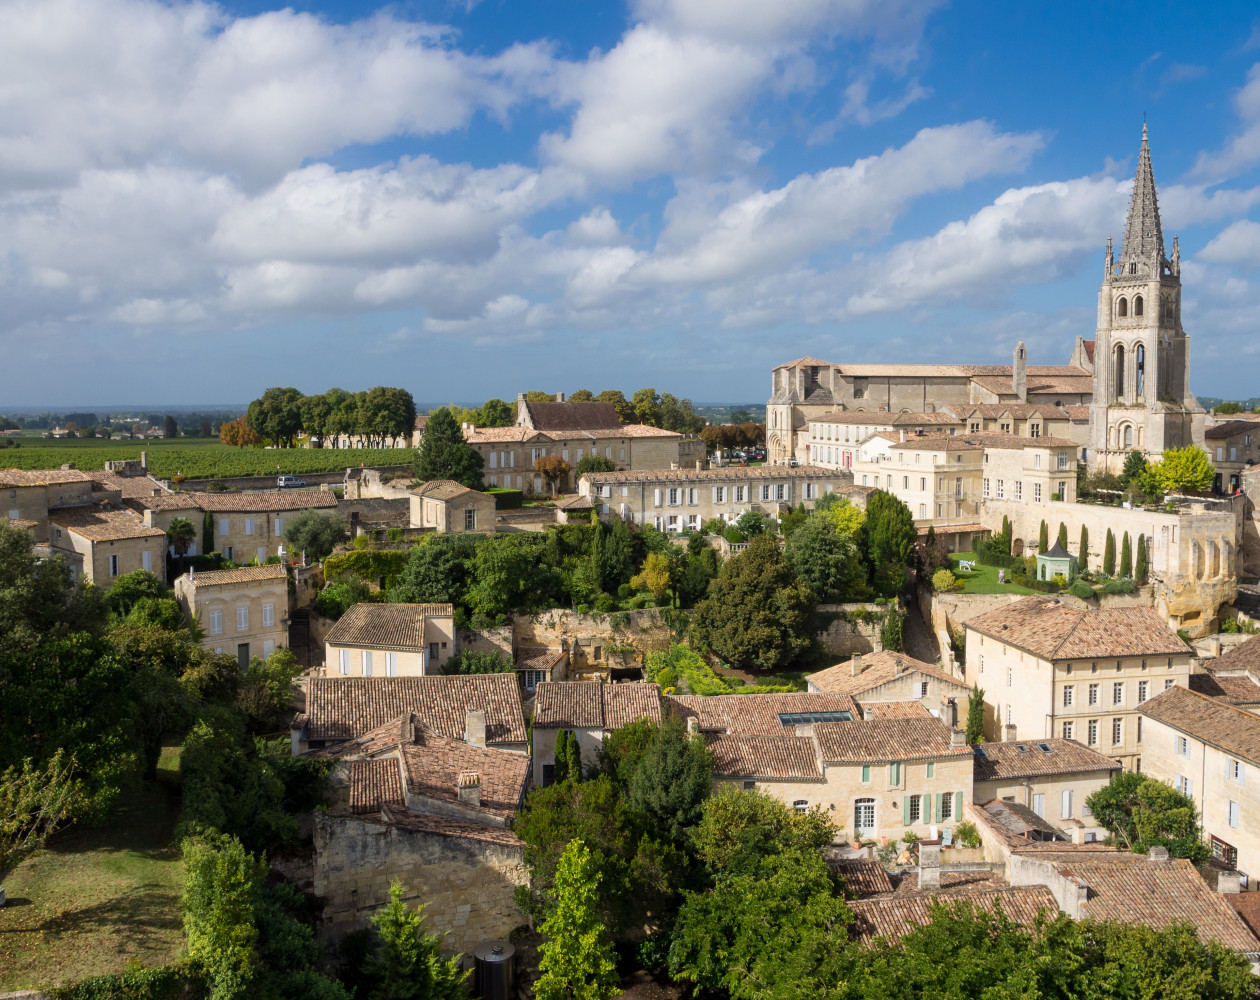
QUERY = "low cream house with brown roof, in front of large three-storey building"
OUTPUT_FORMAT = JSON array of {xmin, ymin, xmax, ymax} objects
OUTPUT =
[{"xmin": 973, "ymin": 737, "xmax": 1121, "ymax": 844}]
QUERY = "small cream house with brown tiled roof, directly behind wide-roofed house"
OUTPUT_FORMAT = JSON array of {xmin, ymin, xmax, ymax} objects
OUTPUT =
[{"xmin": 324, "ymin": 603, "xmax": 456, "ymax": 678}]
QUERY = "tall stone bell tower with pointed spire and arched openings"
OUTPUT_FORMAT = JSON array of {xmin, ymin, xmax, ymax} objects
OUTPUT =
[{"xmin": 1090, "ymin": 125, "xmax": 1203, "ymax": 472}]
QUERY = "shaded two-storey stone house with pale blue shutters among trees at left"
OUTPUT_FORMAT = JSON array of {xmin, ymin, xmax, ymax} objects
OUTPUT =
[{"xmin": 175, "ymin": 564, "xmax": 289, "ymax": 670}]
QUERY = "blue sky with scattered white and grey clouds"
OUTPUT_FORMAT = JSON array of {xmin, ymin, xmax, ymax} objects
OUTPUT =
[{"xmin": 0, "ymin": 0, "xmax": 1260, "ymax": 408}]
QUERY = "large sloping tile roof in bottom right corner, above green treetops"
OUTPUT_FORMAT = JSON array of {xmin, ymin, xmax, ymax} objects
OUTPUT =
[{"xmin": 1055, "ymin": 854, "xmax": 1260, "ymax": 953}]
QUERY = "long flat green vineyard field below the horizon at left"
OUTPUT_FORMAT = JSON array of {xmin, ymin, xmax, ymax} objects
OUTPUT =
[{"xmin": 0, "ymin": 437, "xmax": 415, "ymax": 479}]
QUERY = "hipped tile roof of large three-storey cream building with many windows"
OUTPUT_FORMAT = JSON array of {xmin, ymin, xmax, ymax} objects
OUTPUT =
[{"xmin": 966, "ymin": 596, "xmax": 1191, "ymax": 660}]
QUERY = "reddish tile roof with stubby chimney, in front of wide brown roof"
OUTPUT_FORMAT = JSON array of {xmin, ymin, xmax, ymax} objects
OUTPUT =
[{"xmin": 399, "ymin": 727, "xmax": 530, "ymax": 820}]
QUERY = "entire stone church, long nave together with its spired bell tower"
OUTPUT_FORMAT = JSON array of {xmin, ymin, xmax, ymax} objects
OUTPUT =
[{"xmin": 766, "ymin": 126, "xmax": 1205, "ymax": 471}]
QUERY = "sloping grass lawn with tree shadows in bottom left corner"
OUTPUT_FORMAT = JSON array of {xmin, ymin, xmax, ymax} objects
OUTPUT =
[{"xmin": 0, "ymin": 748, "xmax": 184, "ymax": 991}]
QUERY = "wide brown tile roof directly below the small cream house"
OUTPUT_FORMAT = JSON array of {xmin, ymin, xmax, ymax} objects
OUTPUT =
[{"xmin": 305, "ymin": 674, "xmax": 525, "ymax": 743}]
